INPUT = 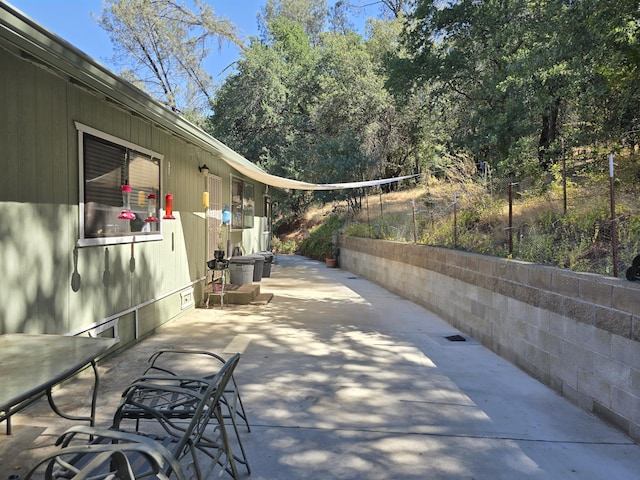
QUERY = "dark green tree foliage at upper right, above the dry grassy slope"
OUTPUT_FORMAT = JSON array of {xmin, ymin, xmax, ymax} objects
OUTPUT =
[{"xmin": 398, "ymin": 0, "xmax": 640, "ymax": 176}]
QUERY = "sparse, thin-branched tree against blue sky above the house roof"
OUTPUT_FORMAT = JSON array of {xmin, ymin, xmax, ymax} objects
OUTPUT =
[{"xmin": 97, "ymin": 0, "xmax": 244, "ymax": 119}]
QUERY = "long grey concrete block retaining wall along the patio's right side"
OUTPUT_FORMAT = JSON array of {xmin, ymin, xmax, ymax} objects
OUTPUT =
[{"xmin": 340, "ymin": 236, "xmax": 640, "ymax": 441}]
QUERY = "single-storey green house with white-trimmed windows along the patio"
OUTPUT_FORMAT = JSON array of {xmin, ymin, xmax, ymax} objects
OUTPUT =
[{"xmin": 0, "ymin": 2, "xmax": 276, "ymax": 345}]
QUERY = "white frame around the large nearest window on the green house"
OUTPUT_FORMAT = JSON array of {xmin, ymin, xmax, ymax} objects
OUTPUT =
[{"xmin": 75, "ymin": 122, "xmax": 164, "ymax": 247}]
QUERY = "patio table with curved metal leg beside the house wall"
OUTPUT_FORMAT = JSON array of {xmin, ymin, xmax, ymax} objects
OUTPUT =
[{"xmin": 0, "ymin": 333, "xmax": 116, "ymax": 435}]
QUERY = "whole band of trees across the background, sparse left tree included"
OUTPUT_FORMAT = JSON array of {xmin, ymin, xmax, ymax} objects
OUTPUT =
[{"xmin": 98, "ymin": 0, "xmax": 640, "ymax": 197}]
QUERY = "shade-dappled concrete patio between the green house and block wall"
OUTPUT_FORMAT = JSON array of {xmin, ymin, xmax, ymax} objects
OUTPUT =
[{"xmin": 0, "ymin": 256, "xmax": 640, "ymax": 480}]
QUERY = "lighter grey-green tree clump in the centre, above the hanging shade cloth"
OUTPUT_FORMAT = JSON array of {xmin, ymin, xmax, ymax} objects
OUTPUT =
[{"xmin": 206, "ymin": 4, "xmax": 435, "ymax": 223}]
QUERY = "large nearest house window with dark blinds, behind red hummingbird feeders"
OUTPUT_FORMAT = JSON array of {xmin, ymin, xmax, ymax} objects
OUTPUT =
[{"xmin": 78, "ymin": 124, "xmax": 162, "ymax": 245}]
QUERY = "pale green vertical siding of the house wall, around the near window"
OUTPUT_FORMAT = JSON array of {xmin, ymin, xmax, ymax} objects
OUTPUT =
[{"xmin": 0, "ymin": 20, "xmax": 264, "ymax": 343}]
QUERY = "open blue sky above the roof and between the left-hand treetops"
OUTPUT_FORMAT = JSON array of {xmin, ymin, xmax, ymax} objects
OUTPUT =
[{"xmin": 7, "ymin": 0, "xmax": 266, "ymax": 83}]
